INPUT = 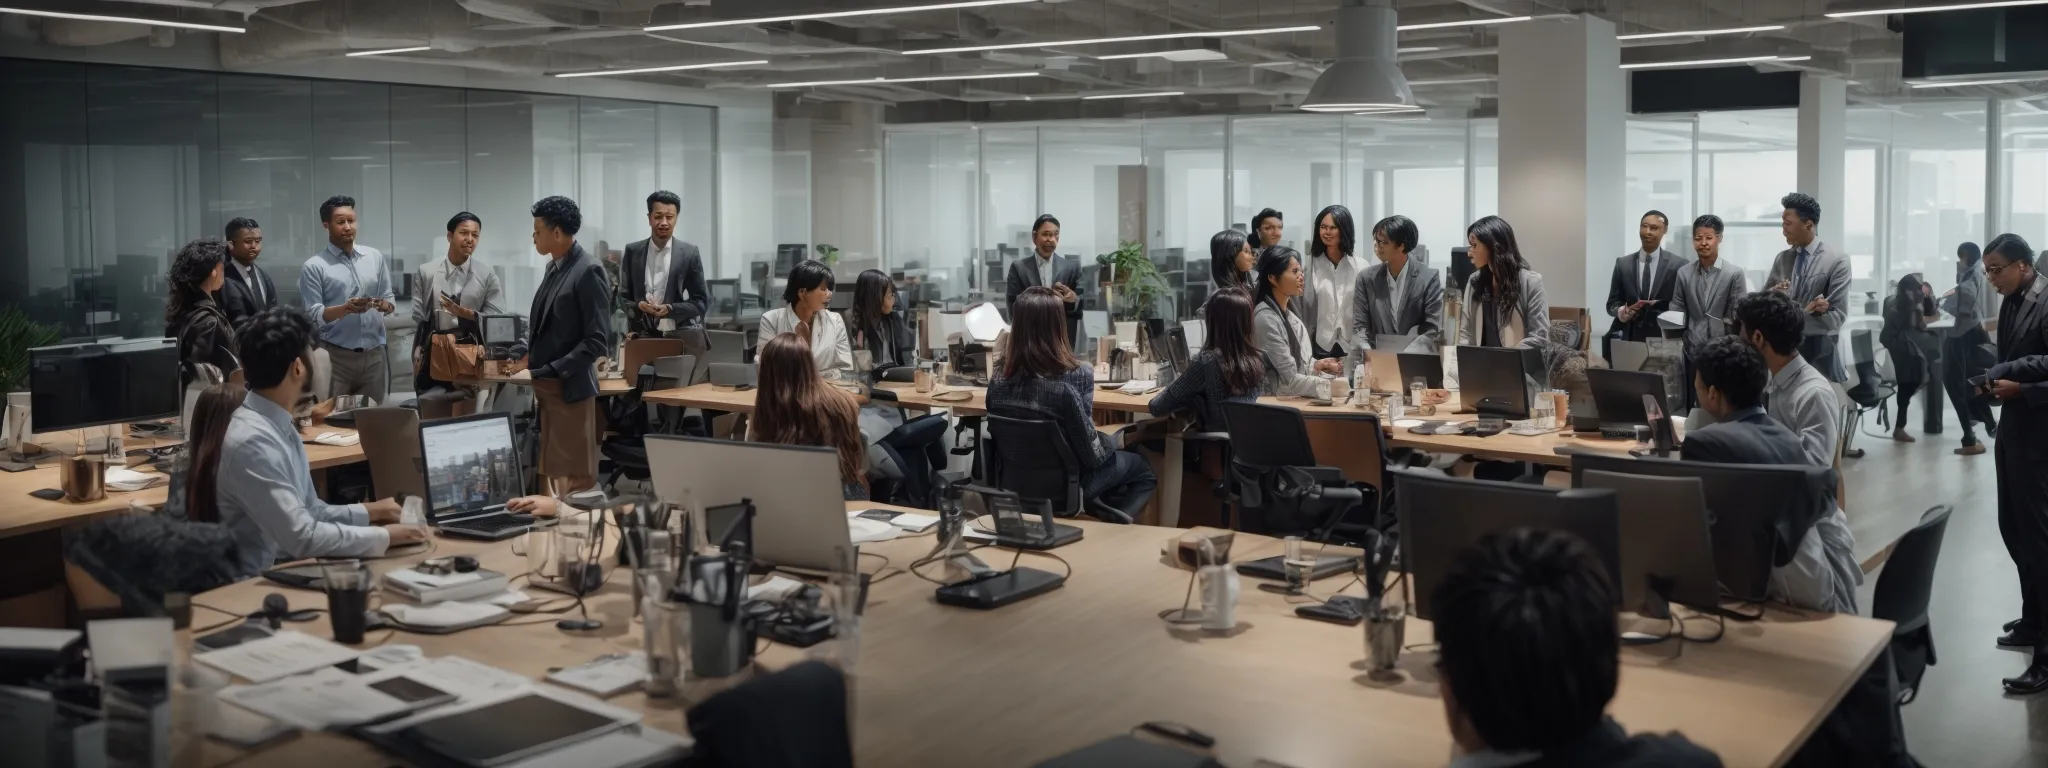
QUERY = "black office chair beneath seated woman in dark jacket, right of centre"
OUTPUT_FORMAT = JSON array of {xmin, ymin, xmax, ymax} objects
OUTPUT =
[{"xmin": 1223, "ymin": 403, "xmax": 1366, "ymax": 541}]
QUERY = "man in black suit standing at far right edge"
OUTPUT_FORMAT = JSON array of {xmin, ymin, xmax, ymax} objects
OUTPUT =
[{"xmin": 1982, "ymin": 236, "xmax": 2048, "ymax": 694}]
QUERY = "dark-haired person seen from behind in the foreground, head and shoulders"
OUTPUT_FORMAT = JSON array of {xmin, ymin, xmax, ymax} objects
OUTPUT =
[{"xmin": 1434, "ymin": 528, "xmax": 1720, "ymax": 768}]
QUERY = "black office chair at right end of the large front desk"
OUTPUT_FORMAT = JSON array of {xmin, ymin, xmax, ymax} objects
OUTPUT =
[{"xmin": 1870, "ymin": 506, "xmax": 1950, "ymax": 705}]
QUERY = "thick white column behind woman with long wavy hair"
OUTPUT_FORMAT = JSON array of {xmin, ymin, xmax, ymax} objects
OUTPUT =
[{"xmin": 1501, "ymin": 16, "xmax": 1634, "ymax": 313}]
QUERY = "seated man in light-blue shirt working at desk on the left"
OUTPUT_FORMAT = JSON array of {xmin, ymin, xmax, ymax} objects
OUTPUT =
[{"xmin": 217, "ymin": 307, "xmax": 426, "ymax": 578}]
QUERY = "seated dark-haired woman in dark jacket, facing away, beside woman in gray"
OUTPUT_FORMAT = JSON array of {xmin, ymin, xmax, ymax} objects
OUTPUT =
[{"xmin": 1147, "ymin": 287, "xmax": 1266, "ymax": 432}]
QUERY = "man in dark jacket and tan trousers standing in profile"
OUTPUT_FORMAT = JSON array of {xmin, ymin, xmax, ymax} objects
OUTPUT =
[{"xmin": 512, "ymin": 197, "xmax": 612, "ymax": 496}]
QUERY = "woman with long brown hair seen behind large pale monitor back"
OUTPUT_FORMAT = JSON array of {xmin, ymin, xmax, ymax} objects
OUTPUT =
[{"xmin": 748, "ymin": 334, "xmax": 868, "ymax": 500}]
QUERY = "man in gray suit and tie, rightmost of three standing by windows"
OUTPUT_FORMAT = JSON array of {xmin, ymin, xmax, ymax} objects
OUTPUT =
[{"xmin": 1763, "ymin": 193, "xmax": 1849, "ymax": 381}]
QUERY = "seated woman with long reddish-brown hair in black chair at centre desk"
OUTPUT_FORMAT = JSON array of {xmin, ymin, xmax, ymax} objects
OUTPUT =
[{"xmin": 987, "ymin": 285, "xmax": 1157, "ymax": 518}]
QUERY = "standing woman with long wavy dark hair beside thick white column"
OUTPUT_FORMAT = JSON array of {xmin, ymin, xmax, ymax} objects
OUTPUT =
[{"xmin": 1458, "ymin": 215, "xmax": 1550, "ymax": 348}]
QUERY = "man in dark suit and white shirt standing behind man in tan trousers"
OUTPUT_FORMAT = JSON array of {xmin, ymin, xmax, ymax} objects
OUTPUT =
[{"xmin": 618, "ymin": 190, "xmax": 707, "ymax": 336}]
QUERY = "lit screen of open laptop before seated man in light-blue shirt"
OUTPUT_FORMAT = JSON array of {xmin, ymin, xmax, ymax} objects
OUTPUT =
[{"xmin": 420, "ymin": 414, "xmax": 520, "ymax": 518}]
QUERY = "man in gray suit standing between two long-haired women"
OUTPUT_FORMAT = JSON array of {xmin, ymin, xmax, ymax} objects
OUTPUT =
[{"xmin": 1352, "ymin": 215, "xmax": 1444, "ymax": 354}]
